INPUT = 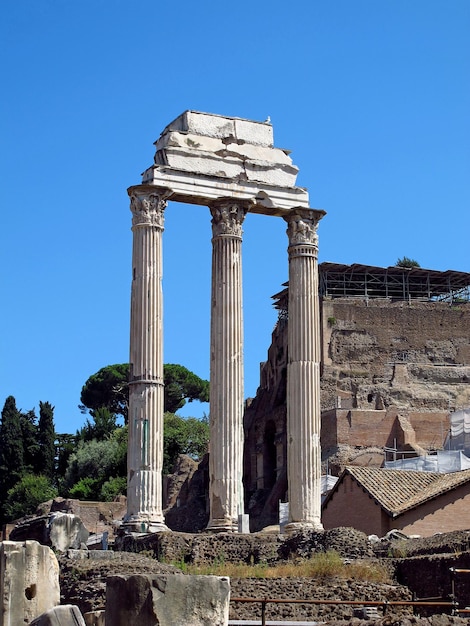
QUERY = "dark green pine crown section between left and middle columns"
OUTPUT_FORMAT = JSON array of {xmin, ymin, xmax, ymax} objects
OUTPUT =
[{"xmin": 163, "ymin": 363, "xmax": 209, "ymax": 413}]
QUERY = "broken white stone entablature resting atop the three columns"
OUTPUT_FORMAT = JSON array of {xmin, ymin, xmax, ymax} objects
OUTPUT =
[{"xmin": 142, "ymin": 111, "xmax": 314, "ymax": 215}]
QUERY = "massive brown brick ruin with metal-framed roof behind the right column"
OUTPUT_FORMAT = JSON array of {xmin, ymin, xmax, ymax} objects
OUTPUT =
[{"xmin": 244, "ymin": 263, "xmax": 470, "ymax": 530}]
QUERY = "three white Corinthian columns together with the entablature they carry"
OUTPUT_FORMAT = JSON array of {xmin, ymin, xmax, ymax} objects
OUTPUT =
[{"xmin": 124, "ymin": 111, "xmax": 324, "ymax": 532}]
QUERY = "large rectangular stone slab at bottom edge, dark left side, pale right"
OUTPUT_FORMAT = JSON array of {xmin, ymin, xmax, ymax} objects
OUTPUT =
[{"xmin": 105, "ymin": 574, "xmax": 230, "ymax": 626}]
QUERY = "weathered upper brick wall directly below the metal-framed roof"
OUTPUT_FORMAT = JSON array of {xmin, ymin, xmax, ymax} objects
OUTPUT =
[{"xmin": 321, "ymin": 298, "xmax": 470, "ymax": 414}]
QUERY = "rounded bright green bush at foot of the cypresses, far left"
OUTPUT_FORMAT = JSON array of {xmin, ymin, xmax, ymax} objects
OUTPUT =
[{"xmin": 5, "ymin": 474, "xmax": 57, "ymax": 521}]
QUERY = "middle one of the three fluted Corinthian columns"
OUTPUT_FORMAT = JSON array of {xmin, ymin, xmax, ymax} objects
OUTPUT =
[{"xmin": 207, "ymin": 200, "xmax": 247, "ymax": 532}]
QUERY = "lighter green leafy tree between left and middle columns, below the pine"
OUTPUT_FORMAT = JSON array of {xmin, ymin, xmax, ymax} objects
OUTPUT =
[{"xmin": 163, "ymin": 413, "xmax": 209, "ymax": 474}]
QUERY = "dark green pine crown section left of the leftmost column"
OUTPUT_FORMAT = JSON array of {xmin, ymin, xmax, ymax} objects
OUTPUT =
[{"xmin": 80, "ymin": 363, "xmax": 129, "ymax": 423}]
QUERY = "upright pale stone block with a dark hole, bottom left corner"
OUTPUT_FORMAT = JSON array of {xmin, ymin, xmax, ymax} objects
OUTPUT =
[{"xmin": 0, "ymin": 541, "xmax": 60, "ymax": 626}]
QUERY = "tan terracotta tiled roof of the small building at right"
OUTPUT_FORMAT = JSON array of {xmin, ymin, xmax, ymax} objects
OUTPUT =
[{"xmin": 338, "ymin": 466, "xmax": 470, "ymax": 517}]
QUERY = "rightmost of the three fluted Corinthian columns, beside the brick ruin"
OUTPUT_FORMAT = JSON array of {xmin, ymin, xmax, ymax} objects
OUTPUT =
[{"xmin": 285, "ymin": 209, "xmax": 323, "ymax": 531}]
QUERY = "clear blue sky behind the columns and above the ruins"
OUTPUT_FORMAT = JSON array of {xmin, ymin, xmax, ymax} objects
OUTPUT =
[{"xmin": 0, "ymin": 0, "xmax": 470, "ymax": 432}]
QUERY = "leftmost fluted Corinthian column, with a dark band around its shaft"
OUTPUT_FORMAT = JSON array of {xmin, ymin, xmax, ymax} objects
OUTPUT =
[{"xmin": 124, "ymin": 185, "xmax": 169, "ymax": 532}]
